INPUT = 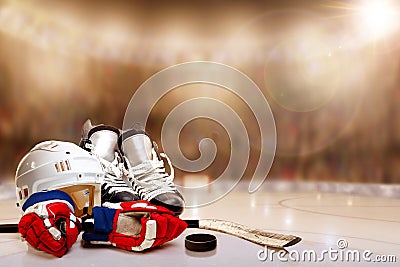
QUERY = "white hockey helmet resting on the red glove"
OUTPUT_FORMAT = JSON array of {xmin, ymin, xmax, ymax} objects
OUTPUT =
[{"xmin": 15, "ymin": 141, "xmax": 104, "ymax": 216}]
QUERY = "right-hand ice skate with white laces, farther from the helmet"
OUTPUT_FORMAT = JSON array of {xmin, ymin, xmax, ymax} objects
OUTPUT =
[{"xmin": 118, "ymin": 126, "xmax": 184, "ymax": 216}]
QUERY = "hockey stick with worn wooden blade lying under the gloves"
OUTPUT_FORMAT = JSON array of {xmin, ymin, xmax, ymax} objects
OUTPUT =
[{"xmin": 0, "ymin": 219, "xmax": 301, "ymax": 248}]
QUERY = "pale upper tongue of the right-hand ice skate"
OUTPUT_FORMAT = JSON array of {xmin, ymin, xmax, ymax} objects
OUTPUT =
[{"xmin": 122, "ymin": 133, "xmax": 153, "ymax": 167}]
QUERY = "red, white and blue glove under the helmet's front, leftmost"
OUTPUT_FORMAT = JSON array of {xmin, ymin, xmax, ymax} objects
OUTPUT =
[{"xmin": 18, "ymin": 190, "xmax": 81, "ymax": 257}]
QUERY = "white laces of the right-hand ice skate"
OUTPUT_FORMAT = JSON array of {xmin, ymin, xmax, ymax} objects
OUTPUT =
[{"xmin": 126, "ymin": 149, "xmax": 176, "ymax": 199}]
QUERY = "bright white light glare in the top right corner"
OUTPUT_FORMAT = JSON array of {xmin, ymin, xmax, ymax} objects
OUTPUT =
[{"xmin": 360, "ymin": 0, "xmax": 398, "ymax": 38}]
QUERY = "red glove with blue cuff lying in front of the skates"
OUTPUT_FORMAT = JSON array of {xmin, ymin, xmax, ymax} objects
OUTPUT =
[{"xmin": 82, "ymin": 200, "xmax": 187, "ymax": 251}]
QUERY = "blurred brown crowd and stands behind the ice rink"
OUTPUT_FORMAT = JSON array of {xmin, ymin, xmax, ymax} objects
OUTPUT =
[{"xmin": 0, "ymin": 0, "xmax": 400, "ymax": 183}]
